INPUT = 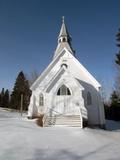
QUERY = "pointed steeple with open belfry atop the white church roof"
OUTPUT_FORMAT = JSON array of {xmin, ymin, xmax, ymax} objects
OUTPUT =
[{"xmin": 53, "ymin": 16, "xmax": 74, "ymax": 58}]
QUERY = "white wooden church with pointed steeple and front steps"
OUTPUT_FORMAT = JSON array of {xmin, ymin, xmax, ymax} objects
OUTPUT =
[{"xmin": 28, "ymin": 18, "xmax": 105, "ymax": 128}]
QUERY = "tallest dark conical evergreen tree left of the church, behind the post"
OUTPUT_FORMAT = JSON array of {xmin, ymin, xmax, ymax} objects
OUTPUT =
[{"xmin": 10, "ymin": 71, "xmax": 31, "ymax": 110}]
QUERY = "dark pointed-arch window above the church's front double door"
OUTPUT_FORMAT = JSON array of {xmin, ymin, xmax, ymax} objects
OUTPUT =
[{"xmin": 57, "ymin": 85, "xmax": 71, "ymax": 96}]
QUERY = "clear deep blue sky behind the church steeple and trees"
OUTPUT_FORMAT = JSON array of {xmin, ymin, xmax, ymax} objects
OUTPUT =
[{"xmin": 0, "ymin": 0, "xmax": 120, "ymax": 98}]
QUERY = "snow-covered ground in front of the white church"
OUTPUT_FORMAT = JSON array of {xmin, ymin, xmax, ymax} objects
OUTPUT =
[{"xmin": 0, "ymin": 108, "xmax": 120, "ymax": 160}]
